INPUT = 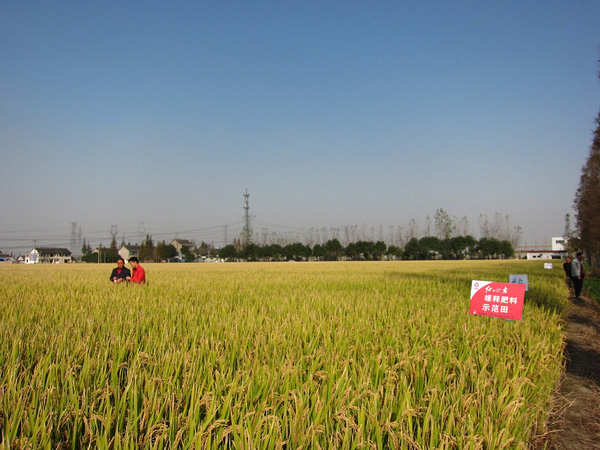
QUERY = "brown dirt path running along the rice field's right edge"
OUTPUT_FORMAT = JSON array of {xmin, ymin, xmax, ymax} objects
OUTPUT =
[{"xmin": 533, "ymin": 298, "xmax": 600, "ymax": 450}]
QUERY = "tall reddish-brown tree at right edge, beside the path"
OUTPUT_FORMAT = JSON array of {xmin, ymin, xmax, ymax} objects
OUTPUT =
[{"xmin": 575, "ymin": 113, "xmax": 600, "ymax": 268}]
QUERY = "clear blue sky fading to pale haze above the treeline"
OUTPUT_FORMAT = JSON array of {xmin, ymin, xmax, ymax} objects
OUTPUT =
[{"xmin": 0, "ymin": 0, "xmax": 600, "ymax": 253}]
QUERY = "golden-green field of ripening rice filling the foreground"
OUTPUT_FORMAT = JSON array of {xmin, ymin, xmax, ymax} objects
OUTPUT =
[{"xmin": 0, "ymin": 261, "xmax": 568, "ymax": 449}]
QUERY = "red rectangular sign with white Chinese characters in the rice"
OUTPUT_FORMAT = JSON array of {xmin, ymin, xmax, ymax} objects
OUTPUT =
[{"xmin": 469, "ymin": 281, "xmax": 526, "ymax": 320}]
